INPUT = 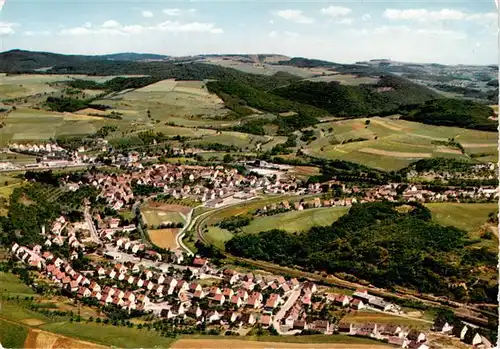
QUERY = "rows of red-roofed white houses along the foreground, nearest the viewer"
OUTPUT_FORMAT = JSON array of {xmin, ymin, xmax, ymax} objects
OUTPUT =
[{"xmin": 7, "ymin": 239, "xmax": 492, "ymax": 349}]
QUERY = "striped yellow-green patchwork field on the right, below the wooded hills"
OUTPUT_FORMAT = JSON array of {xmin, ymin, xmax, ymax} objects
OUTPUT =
[{"xmin": 304, "ymin": 117, "xmax": 498, "ymax": 170}]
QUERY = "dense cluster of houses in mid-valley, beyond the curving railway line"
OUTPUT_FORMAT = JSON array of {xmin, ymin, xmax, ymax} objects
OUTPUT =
[{"xmin": 62, "ymin": 164, "xmax": 298, "ymax": 210}]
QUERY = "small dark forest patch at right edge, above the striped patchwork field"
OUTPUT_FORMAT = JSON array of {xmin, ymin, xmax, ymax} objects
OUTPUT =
[{"xmin": 400, "ymin": 98, "xmax": 498, "ymax": 132}]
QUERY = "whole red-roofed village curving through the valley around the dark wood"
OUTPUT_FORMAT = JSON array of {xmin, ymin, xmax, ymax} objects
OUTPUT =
[{"xmin": 1, "ymin": 150, "xmax": 498, "ymax": 349}]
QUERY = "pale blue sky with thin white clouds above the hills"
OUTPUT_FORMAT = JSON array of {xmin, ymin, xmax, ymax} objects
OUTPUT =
[{"xmin": 0, "ymin": 0, "xmax": 499, "ymax": 64}]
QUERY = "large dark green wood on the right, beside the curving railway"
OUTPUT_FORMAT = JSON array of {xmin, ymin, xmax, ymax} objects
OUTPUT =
[{"xmin": 226, "ymin": 202, "xmax": 498, "ymax": 302}]
